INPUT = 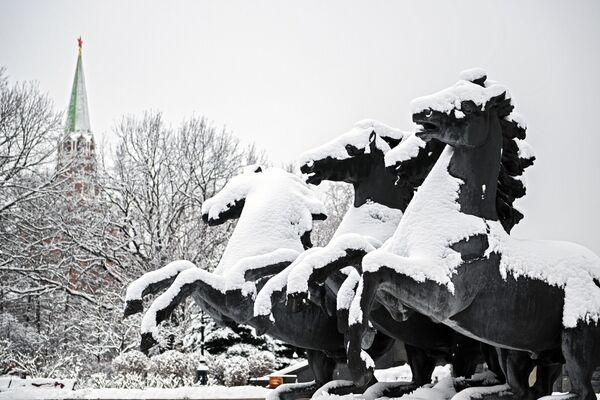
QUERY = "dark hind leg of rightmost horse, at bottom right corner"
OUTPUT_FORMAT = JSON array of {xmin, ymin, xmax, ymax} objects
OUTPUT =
[{"xmin": 561, "ymin": 322, "xmax": 600, "ymax": 400}]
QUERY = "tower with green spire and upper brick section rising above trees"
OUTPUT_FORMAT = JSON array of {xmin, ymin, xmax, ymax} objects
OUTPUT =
[{"xmin": 57, "ymin": 37, "xmax": 96, "ymax": 194}]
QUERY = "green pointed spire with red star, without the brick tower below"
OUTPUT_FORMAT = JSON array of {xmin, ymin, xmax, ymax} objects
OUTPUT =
[{"xmin": 65, "ymin": 38, "xmax": 91, "ymax": 133}]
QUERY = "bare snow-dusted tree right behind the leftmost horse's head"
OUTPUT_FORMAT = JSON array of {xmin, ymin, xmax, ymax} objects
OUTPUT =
[{"xmin": 108, "ymin": 112, "xmax": 244, "ymax": 274}]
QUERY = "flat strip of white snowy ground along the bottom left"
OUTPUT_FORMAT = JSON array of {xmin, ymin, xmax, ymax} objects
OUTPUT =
[{"xmin": 0, "ymin": 386, "xmax": 271, "ymax": 400}]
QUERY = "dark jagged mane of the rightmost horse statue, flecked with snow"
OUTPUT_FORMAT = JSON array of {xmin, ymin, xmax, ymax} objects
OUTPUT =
[{"xmin": 471, "ymin": 75, "xmax": 535, "ymax": 233}]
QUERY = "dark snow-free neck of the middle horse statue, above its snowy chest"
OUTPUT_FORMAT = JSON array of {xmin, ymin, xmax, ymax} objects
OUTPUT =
[{"xmin": 353, "ymin": 154, "xmax": 409, "ymax": 211}]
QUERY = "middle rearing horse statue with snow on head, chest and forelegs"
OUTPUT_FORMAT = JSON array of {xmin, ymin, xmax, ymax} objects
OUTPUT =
[{"xmin": 255, "ymin": 120, "xmax": 501, "ymax": 396}]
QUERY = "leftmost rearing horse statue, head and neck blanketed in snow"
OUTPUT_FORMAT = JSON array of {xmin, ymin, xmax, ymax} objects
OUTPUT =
[{"xmin": 126, "ymin": 165, "xmax": 391, "ymax": 398}]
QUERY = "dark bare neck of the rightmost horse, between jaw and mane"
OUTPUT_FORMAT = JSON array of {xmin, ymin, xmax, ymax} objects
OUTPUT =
[{"xmin": 448, "ymin": 118, "xmax": 502, "ymax": 220}]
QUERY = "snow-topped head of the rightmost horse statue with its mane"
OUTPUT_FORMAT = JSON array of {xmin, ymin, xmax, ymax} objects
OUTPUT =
[{"xmin": 411, "ymin": 72, "xmax": 535, "ymax": 232}]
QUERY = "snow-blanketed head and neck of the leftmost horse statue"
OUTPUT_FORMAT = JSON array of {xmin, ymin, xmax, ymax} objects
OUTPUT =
[{"xmin": 202, "ymin": 168, "xmax": 324, "ymax": 274}]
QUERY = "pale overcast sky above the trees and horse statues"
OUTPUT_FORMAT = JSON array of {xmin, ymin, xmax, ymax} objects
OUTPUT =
[{"xmin": 0, "ymin": 0, "xmax": 600, "ymax": 253}]
